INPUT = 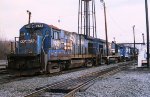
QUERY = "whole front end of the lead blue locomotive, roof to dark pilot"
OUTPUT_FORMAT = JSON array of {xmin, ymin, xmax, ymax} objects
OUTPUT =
[{"xmin": 7, "ymin": 23, "xmax": 50, "ymax": 72}]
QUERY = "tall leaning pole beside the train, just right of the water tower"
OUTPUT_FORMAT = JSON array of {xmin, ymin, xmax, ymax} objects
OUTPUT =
[{"xmin": 100, "ymin": 0, "xmax": 108, "ymax": 64}]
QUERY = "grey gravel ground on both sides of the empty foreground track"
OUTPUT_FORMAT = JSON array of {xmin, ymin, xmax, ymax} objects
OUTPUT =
[{"xmin": 0, "ymin": 61, "xmax": 150, "ymax": 97}]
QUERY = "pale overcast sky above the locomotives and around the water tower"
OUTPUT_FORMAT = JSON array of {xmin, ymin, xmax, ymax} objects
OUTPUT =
[{"xmin": 0, "ymin": 0, "xmax": 150, "ymax": 42}]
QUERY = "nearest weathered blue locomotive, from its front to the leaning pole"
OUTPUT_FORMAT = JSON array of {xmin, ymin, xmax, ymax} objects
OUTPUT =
[{"xmin": 7, "ymin": 23, "xmax": 105, "ymax": 73}]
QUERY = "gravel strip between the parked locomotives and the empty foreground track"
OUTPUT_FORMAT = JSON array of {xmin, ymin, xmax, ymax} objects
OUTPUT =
[{"xmin": 0, "ymin": 64, "xmax": 117, "ymax": 97}]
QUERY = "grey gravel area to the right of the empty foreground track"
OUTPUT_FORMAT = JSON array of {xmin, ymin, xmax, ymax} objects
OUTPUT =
[{"xmin": 76, "ymin": 68, "xmax": 150, "ymax": 97}]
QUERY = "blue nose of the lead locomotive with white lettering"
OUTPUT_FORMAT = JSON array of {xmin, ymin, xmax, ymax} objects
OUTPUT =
[{"xmin": 19, "ymin": 29, "xmax": 42, "ymax": 54}]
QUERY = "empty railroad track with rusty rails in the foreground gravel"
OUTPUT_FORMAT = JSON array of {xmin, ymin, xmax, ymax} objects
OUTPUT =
[{"xmin": 25, "ymin": 63, "xmax": 131, "ymax": 97}]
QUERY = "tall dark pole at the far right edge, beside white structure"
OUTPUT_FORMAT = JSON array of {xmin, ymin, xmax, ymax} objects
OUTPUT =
[{"xmin": 145, "ymin": 0, "xmax": 149, "ymax": 68}]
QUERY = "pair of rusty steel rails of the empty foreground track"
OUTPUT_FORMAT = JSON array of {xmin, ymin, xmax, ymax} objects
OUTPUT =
[{"xmin": 24, "ymin": 63, "xmax": 133, "ymax": 97}]
